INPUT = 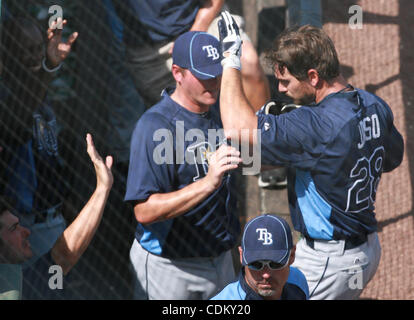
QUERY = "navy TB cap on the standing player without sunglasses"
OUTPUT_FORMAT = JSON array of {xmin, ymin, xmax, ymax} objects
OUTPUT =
[{"xmin": 172, "ymin": 31, "xmax": 223, "ymax": 80}]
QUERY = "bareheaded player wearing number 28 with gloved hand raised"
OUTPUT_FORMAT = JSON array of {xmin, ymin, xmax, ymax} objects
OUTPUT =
[{"xmin": 219, "ymin": 12, "xmax": 404, "ymax": 299}]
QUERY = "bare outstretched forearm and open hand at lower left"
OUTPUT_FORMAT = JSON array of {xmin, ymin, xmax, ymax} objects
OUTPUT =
[{"xmin": 51, "ymin": 134, "xmax": 113, "ymax": 274}]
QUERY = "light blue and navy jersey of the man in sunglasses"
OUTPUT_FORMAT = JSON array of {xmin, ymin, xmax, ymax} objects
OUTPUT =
[{"xmin": 211, "ymin": 267, "xmax": 309, "ymax": 300}]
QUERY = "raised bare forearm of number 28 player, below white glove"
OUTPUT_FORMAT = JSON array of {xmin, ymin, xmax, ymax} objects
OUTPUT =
[{"xmin": 220, "ymin": 68, "xmax": 257, "ymax": 144}]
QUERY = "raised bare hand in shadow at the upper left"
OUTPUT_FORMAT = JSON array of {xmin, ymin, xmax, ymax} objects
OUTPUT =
[{"xmin": 47, "ymin": 17, "xmax": 78, "ymax": 68}]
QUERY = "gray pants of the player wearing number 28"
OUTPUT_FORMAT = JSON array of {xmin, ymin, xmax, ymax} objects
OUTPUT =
[{"xmin": 293, "ymin": 232, "xmax": 381, "ymax": 300}]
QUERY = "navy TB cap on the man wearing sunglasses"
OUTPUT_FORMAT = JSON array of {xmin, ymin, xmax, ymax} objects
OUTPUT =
[{"xmin": 241, "ymin": 214, "xmax": 293, "ymax": 266}]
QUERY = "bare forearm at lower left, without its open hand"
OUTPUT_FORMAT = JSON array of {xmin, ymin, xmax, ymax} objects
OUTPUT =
[{"xmin": 52, "ymin": 187, "xmax": 110, "ymax": 274}]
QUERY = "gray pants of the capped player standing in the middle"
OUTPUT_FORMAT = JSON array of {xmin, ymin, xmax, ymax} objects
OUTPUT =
[{"xmin": 130, "ymin": 240, "xmax": 236, "ymax": 300}]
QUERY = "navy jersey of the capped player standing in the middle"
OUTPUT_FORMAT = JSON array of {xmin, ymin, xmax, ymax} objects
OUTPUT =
[{"xmin": 125, "ymin": 87, "xmax": 240, "ymax": 258}]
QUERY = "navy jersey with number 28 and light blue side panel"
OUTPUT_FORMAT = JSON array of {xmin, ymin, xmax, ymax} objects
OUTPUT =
[{"xmin": 258, "ymin": 89, "xmax": 404, "ymax": 240}]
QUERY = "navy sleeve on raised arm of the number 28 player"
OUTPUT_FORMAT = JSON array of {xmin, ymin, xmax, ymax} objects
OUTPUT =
[{"xmin": 257, "ymin": 107, "xmax": 332, "ymax": 170}]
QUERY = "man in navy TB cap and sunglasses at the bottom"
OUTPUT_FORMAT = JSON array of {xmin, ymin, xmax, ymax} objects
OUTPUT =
[{"xmin": 212, "ymin": 214, "xmax": 309, "ymax": 300}]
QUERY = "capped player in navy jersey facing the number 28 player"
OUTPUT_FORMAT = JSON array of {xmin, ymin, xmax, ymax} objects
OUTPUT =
[{"xmin": 125, "ymin": 31, "xmax": 241, "ymax": 300}]
